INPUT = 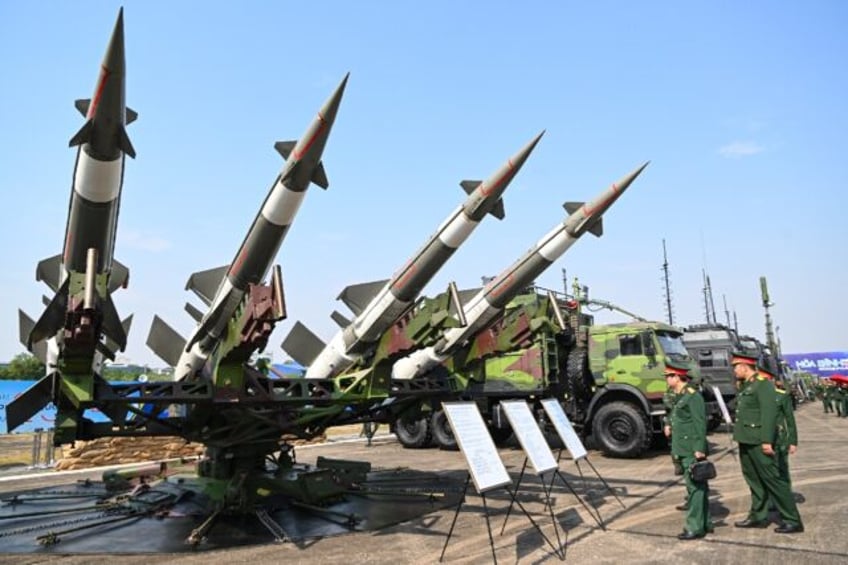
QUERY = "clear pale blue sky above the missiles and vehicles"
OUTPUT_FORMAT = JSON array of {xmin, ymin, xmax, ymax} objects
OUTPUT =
[{"xmin": 0, "ymin": 0, "xmax": 848, "ymax": 366}]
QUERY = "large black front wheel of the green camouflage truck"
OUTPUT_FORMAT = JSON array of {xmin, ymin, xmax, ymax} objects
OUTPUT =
[{"xmin": 592, "ymin": 401, "xmax": 651, "ymax": 458}]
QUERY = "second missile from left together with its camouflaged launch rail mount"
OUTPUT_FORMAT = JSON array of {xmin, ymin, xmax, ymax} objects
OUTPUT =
[{"xmin": 147, "ymin": 75, "xmax": 348, "ymax": 380}]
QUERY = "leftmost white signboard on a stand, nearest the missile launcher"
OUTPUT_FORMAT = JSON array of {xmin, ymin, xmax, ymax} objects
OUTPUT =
[{"xmin": 442, "ymin": 402, "xmax": 512, "ymax": 493}]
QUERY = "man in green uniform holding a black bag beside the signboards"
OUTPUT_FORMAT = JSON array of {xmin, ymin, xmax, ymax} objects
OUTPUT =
[{"xmin": 665, "ymin": 361, "xmax": 713, "ymax": 540}]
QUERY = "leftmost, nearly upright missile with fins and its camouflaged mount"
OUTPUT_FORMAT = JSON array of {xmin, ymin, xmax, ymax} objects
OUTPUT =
[{"xmin": 7, "ymin": 9, "xmax": 136, "ymax": 430}]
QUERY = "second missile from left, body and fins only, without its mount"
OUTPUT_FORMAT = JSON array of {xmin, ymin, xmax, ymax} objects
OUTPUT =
[{"xmin": 156, "ymin": 76, "xmax": 348, "ymax": 380}]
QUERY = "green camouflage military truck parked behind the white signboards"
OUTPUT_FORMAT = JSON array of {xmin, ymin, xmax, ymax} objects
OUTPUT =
[{"xmin": 393, "ymin": 287, "xmax": 697, "ymax": 457}]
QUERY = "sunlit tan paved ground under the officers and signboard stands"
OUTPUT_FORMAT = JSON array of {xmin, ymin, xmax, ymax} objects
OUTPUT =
[{"xmin": 0, "ymin": 403, "xmax": 848, "ymax": 565}]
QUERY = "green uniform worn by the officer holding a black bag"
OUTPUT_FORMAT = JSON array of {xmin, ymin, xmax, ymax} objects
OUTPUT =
[{"xmin": 671, "ymin": 386, "xmax": 713, "ymax": 536}]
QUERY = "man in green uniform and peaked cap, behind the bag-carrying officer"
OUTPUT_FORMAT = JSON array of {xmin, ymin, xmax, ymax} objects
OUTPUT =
[{"xmin": 731, "ymin": 353, "xmax": 804, "ymax": 534}]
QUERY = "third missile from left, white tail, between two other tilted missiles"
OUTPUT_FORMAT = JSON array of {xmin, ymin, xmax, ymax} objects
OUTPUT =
[{"xmin": 283, "ymin": 132, "xmax": 544, "ymax": 379}]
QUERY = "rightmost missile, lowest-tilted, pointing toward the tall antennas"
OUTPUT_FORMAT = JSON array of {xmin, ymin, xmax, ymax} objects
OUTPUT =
[{"xmin": 392, "ymin": 163, "xmax": 647, "ymax": 379}]
